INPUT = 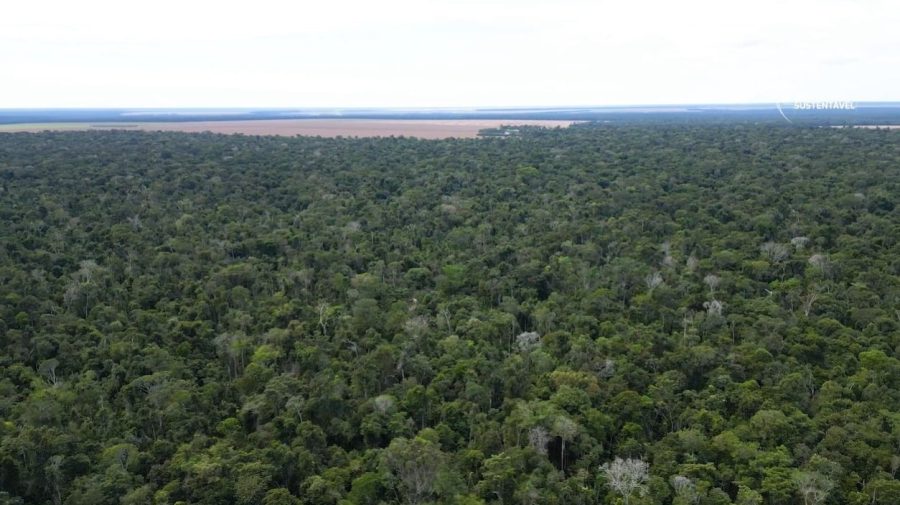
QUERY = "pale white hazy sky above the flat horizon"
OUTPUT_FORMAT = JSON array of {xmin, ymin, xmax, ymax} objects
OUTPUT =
[{"xmin": 0, "ymin": 0, "xmax": 900, "ymax": 107}]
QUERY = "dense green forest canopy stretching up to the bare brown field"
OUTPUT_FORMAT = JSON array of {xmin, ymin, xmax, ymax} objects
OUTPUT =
[{"xmin": 0, "ymin": 125, "xmax": 900, "ymax": 505}]
